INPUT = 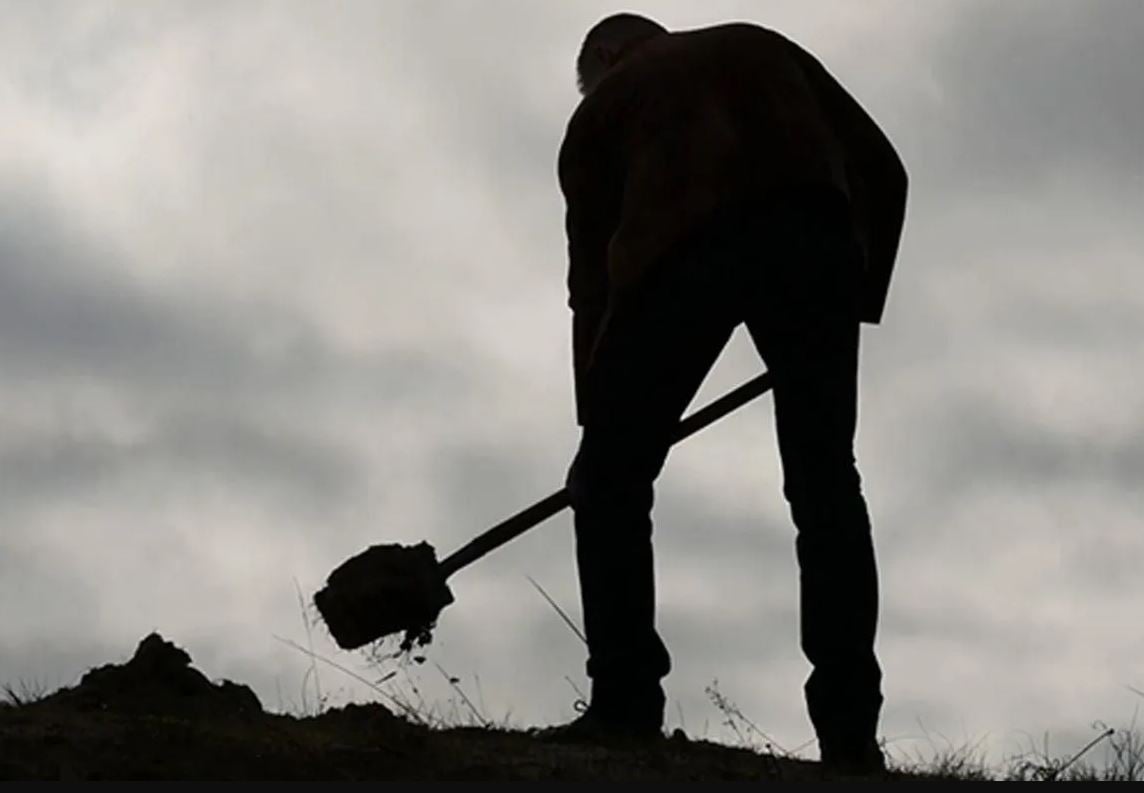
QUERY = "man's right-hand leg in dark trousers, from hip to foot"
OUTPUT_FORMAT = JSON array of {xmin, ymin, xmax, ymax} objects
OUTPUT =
[{"xmin": 748, "ymin": 197, "xmax": 882, "ymax": 767}]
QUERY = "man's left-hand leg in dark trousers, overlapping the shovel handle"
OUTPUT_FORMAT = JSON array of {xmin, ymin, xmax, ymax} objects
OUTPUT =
[{"xmin": 569, "ymin": 250, "xmax": 737, "ymax": 730}]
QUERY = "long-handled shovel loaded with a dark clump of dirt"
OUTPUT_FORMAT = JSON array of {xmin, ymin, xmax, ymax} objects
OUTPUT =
[{"xmin": 313, "ymin": 372, "xmax": 772, "ymax": 652}]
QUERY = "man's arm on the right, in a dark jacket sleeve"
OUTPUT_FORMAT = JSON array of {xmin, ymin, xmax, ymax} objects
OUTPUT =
[{"xmin": 794, "ymin": 46, "xmax": 908, "ymax": 324}]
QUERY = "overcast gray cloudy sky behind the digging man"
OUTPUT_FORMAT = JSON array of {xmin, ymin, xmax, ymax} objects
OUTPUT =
[{"xmin": 0, "ymin": 0, "xmax": 1144, "ymax": 759}]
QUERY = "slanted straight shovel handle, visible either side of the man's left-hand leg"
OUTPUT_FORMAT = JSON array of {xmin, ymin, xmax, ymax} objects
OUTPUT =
[{"xmin": 440, "ymin": 372, "xmax": 773, "ymax": 578}]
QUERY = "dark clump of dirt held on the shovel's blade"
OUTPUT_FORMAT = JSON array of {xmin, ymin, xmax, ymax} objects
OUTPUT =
[{"xmin": 313, "ymin": 542, "xmax": 453, "ymax": 652}]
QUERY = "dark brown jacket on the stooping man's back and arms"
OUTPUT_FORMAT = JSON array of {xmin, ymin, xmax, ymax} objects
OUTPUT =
[{"xmin": 558, "ymin": 23, "xmax": 906, "ymax": 416}]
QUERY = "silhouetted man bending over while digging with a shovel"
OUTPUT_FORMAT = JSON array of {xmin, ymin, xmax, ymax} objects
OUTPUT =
[{"xmin": 542, "ymin": 14, "xmax": 906, "ymax": 770}]
